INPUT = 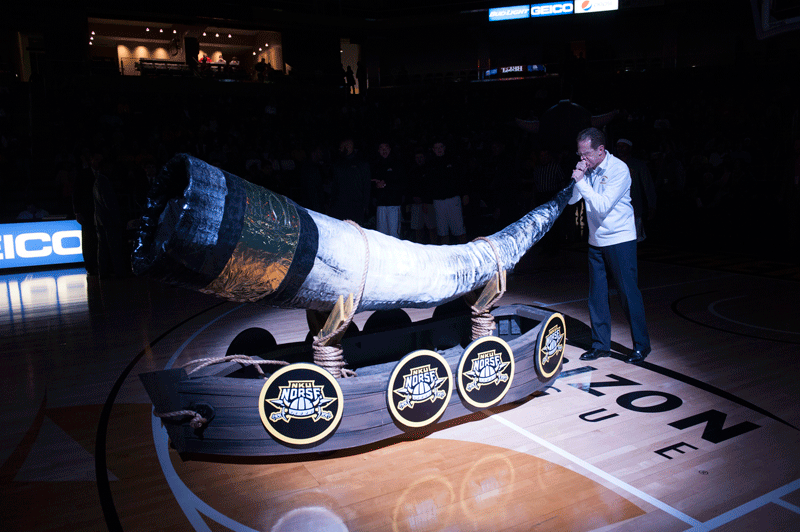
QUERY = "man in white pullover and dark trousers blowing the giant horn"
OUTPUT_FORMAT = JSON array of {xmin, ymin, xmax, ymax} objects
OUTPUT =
[{"xmin": 570, "ymin": 127, "xmax": 650, "ymax": 363}]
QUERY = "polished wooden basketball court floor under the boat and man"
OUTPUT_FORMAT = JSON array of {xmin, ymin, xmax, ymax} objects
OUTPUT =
[{"xmin": 0, "ymin": 246, "xmax": 800, "ymax": 532}]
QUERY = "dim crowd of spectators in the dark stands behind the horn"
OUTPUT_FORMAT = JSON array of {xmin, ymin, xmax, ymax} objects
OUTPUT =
[{"xmin": 0, "ymin": 63, "xmax": 800, "ymax": 274}]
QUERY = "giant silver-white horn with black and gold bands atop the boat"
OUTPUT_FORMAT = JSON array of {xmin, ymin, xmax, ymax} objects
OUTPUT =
[{"xmin": 132, "ymin": 155, "xmax": 572, "ymax": 311}]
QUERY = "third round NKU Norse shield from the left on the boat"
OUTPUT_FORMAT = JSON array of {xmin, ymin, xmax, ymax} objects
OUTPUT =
[{"xmin": 457, "ymin": 336, "xmax": 514, "ymax": 408}]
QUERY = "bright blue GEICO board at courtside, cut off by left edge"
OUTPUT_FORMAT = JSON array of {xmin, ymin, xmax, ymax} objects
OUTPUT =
[{"xmin": 0, "ymin": 220, "xmax": 83, "ymax": 269}]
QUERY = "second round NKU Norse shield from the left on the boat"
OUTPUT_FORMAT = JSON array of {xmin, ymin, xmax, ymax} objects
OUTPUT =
[{"xmin": 387, "ymin": 349, "xmax": 453, "ymax": 427}]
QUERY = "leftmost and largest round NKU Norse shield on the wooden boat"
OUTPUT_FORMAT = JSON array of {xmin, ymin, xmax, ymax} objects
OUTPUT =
[{"xmin": 258, "ymin": 363, "xmax": 344, "ymax": 445}]
